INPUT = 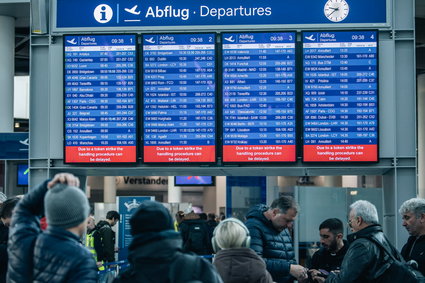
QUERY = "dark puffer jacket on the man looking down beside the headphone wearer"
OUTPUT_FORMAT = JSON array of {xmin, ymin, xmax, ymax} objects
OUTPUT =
[{"xmin": 245, "ymin": 204, "xmax": 296, "ymax": 283}]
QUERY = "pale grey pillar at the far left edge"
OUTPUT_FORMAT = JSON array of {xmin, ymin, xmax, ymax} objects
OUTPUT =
[{"xmin": 0, "ymin": 16, "xmax": 15, "ymax": 132}]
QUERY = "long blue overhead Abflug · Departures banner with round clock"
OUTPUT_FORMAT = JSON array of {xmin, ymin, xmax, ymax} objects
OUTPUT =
[{"xmin": 55, "ymin": 0, "xmax": 387, "ymax": 30}]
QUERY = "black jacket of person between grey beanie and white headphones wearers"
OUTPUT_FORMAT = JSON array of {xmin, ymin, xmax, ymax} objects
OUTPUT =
[{"xmin": 114, "ymin": 230, "xmax": 222, "ymax": 283}]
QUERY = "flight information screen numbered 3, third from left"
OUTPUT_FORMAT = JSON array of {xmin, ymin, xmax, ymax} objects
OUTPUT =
[{"xmin": 222, "ymin": 33, "xmax": 296, "ymax": 162}]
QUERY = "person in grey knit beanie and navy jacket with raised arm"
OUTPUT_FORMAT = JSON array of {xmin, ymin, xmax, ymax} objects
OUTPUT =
[{"xmin": 7, "ymin": 173, "xmax": 97, "ymax": 283}]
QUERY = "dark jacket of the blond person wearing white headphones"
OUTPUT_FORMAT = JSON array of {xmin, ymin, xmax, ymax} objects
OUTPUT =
[{"xmin": 214, "ymin": 248, "xmax": 273, "ymax": 283}]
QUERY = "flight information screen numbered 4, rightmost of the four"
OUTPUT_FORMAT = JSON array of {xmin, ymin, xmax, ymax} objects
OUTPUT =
[{"xmin": 302, "ymin": 31, "xmax": 378, "ymax": 162}]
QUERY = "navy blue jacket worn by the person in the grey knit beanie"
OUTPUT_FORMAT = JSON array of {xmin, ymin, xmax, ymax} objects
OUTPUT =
[{"xmin": 7, "ymin": 181, "xmax": 97, "ymax": 283}]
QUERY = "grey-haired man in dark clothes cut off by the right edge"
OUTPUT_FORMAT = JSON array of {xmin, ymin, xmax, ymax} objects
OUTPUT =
[{"xmin": 399, "ymin": 198, "xmax": 425, "ymax": 274}]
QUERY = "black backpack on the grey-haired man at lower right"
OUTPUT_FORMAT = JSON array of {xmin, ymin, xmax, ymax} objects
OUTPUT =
[{"xmin": 366, "ymin": 237, "xmax": 425, "ymax": 283}]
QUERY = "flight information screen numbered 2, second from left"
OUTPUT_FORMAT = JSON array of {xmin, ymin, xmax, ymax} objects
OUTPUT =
[{"xmin": 143, "ymin": 34, "xmax": 216, "ymax": 163}]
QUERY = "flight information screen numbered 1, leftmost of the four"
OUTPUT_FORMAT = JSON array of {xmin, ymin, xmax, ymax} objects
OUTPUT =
[{"xmin": 64, "ymin": 35, "xmax": 137, "ymax": 163}]
